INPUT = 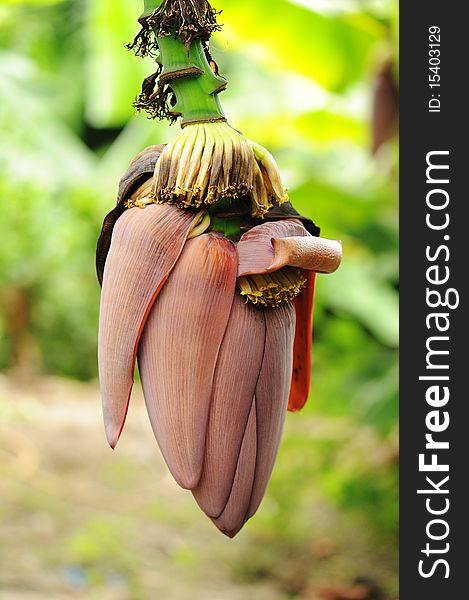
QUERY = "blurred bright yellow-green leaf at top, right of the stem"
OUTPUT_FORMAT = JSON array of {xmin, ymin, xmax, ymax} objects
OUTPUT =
[{"xmin": 215, "ymin": 0, "xmax": 384, "ymax": 92}]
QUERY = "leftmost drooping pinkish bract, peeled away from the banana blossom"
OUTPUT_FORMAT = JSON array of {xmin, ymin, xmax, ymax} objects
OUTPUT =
[{"xmin": 98, "ymin": 205, "xmax": 200, "ymax": 448}]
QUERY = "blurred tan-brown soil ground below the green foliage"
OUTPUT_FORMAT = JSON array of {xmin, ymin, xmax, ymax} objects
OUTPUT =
[{"xmin": 0, "ymin": 376, "xmax": 395, "ymax": 600}]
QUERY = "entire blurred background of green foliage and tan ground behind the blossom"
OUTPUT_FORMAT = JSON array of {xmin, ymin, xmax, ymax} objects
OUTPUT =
[{"xmin": 0, "ymin": 0, "xmax": 398, "ymax": 600}]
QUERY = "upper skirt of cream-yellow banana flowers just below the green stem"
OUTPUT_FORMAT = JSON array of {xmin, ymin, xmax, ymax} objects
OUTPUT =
[{"xmin": 143, "ymin": 121, "xmax": 288, "ymax": 217}]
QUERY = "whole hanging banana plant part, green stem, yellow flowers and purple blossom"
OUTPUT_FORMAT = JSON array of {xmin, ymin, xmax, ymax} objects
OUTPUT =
[{"xmin": 97, "ymin": 0, "xmax": 342, "ymax": 537}]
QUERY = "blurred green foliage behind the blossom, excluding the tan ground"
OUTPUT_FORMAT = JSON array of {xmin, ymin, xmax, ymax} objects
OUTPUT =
[{"xmin": 0, "ymin": 0, "xmax": 398, "ymax": 596}]
